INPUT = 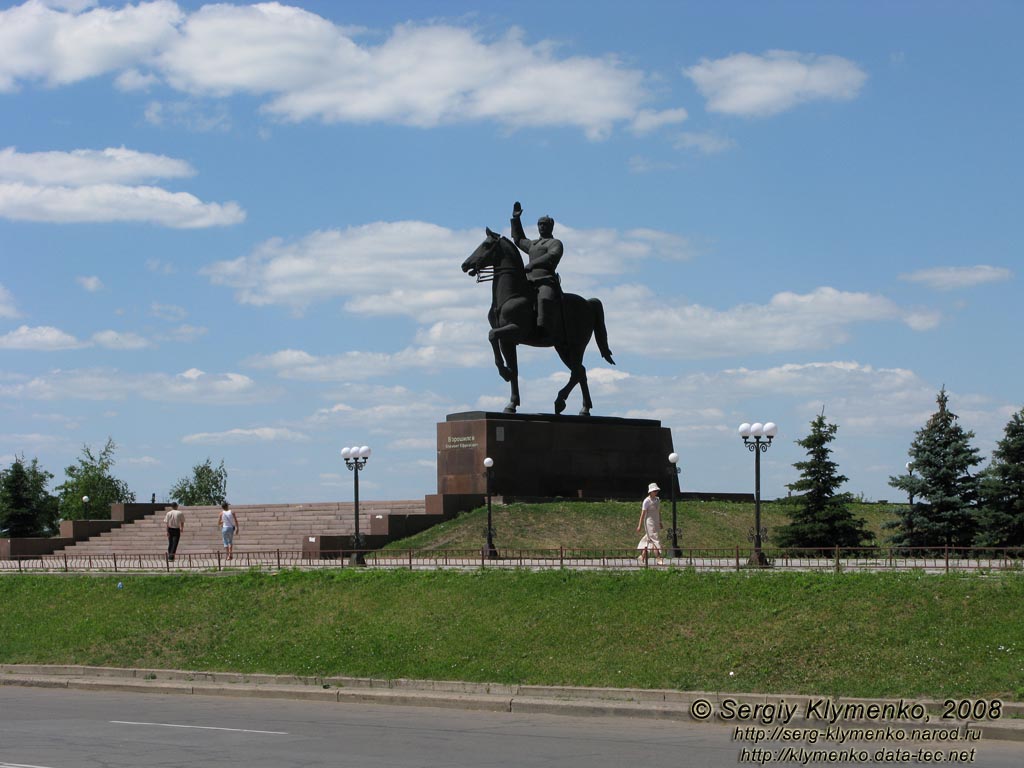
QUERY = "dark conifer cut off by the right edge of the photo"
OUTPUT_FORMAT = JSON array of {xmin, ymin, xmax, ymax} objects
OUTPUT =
[{"xmin": 975, "ymin": 409, "xmax": 1024, "ymax": 547}]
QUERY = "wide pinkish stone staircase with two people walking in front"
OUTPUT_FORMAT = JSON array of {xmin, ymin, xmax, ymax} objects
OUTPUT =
[{"xmin": 55, "ymin": 500, "xmax": 428, "ymax": 557}]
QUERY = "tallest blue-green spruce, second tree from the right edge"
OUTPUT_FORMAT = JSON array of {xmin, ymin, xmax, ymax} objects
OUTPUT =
[{"xmin": 886, "ymin": 387, "xmax": 982, "ymax": 547}]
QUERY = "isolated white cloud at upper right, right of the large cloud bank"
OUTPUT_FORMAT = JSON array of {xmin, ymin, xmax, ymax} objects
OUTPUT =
[{"xmin": 684, "ymin": 50, "xmax": 867, "ymax": 117}]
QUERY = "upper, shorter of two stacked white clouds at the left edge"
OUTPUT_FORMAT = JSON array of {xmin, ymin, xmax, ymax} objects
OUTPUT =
[{"xmin": 0, "ymin": 146, "xmax": 196, "ymax": 186}]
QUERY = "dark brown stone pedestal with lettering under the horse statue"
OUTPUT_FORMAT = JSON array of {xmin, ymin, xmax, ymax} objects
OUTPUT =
[{"xmin": 437, "ymin": 411, "xmax": 679, "ymax": 504}]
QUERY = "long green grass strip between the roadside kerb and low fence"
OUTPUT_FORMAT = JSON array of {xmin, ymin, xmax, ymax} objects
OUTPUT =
[{"xmin": 0, "ymin": 573, "xmax": 1024, "ymax": 699}]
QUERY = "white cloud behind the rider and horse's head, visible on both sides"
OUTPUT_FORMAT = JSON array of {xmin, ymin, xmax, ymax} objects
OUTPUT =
[{"xmin": 201, "ymin": 221, "xmax": 694, "ymax": 315}]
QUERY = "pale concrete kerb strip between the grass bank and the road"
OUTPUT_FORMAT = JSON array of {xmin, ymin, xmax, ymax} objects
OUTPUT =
[{"xmin": 0, "ymin": 665, "xmax": 1024, "ymax": 746}]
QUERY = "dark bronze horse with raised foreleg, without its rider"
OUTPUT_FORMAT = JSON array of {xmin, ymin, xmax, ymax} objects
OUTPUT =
[{"xmin": 462, "ymin": 229, "xmax": 615, "ymax": 416}]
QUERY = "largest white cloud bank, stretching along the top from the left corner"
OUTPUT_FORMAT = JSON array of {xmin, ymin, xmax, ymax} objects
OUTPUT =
[{"xmin": 0, "ymin": 2, "xmax": 685, "ymax": 139}]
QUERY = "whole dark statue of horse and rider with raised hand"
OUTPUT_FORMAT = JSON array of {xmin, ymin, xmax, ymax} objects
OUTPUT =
[{"xmin": 462, "ymin": 202, "xmax": 615, "ymax": 416}]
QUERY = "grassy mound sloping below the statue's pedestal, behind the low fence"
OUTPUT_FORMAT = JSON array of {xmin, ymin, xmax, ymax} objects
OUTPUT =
[{"xmin": 389, "ymin": 500, "xmax": 897, "ymax": 550}]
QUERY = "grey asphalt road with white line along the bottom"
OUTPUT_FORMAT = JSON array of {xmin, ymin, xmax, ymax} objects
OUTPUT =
[{"xmin": 0, "ymin": 687, "xmax": 1024, "ymax": 768}]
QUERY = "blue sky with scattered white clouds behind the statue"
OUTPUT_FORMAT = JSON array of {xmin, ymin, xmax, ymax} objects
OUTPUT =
[{"xmin": 0, "ymin": 0, "xmax": 1024, "ymax": 504}]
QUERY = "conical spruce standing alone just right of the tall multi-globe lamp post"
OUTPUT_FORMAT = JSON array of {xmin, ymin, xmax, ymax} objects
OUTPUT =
[{"xmin": 775, "ymin": 411, "xmax": 870, "ymax": 548}]
